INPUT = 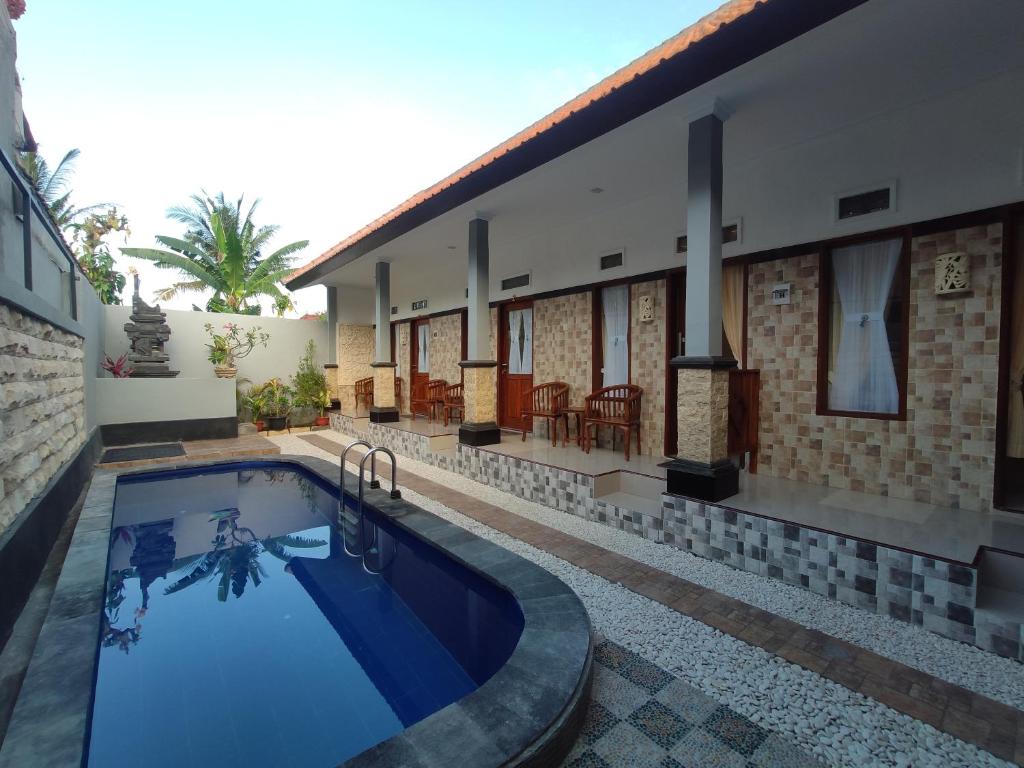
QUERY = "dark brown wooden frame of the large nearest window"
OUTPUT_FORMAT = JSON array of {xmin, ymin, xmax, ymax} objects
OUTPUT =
[{"xmin": 815, "ymin": 227, "xmax": 910, "ymax": 421}]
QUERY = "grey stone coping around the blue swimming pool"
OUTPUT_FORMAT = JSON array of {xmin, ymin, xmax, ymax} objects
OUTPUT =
[{"xmin": 0, "ymin": 455, "xmax": 594, "ymax": 768}]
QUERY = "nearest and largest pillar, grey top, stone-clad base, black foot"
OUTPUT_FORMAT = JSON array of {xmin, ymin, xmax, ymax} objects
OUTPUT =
[{"xmin": 668, "ymin": 103, "xmax": 739, "ymax": 502}]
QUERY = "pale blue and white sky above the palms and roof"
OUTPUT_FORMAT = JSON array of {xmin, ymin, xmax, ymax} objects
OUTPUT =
[{"xmin": 14, "ymin": 0, "xmax": 720, "ymax": 314}]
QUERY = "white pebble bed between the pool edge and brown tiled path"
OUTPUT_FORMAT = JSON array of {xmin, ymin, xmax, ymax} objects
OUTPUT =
[{"xmin": 274, "ymin": 437, "xmax": 1009, "ymax": 768}]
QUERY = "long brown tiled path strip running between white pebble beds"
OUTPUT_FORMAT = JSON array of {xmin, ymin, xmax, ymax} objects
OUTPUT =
[{"xmin": 301, "ymin": 434, "xmax": 1024, "ymax": 764}]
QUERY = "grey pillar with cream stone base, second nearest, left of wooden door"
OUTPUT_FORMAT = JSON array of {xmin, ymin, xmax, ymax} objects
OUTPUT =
[{"xmin": 459, "ymin": 218, "xmax": 502, "ymax": 445}]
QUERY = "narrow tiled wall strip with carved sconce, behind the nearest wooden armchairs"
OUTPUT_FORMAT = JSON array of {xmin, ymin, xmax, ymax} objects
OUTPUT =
[{"xmin": 630, "ymin": 280, "xmax": 667, "ymax": 456}]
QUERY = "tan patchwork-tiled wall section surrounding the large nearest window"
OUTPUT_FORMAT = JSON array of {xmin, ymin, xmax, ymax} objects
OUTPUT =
[{"xmin": 748, "ymin": 224, "xmax": 1001, "ymax": 511}]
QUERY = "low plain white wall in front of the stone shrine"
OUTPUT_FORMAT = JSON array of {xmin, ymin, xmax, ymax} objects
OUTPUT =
[{"xmin": 94, "ymin": 377, "xmax": 236, "ymax": 424}]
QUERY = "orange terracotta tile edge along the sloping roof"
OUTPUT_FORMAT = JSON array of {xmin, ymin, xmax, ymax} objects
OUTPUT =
[{"xmin": 287, "ymin": 0, "xmax": 769, "ymax": 282}]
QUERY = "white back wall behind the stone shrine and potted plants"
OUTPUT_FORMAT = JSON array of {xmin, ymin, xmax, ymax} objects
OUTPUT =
[{"xmin": 102, "ymin": 307, "xmax": 328, "ymax": 387}]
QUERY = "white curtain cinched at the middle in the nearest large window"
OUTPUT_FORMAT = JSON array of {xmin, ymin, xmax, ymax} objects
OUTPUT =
[{"xmin": 828, "ymin": 240, "xmax": 902, "ymax": 414}]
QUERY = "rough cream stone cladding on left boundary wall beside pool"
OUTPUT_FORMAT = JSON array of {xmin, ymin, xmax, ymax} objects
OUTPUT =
[{"xmin": 0, "ymin": 303, "xmax": 85, "ymax": 532}]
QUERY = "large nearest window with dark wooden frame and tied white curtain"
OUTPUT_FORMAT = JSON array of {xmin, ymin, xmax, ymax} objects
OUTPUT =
[{"xmin": 818, "ymin": 238, "xmax": 908, "ymax": 418}]
